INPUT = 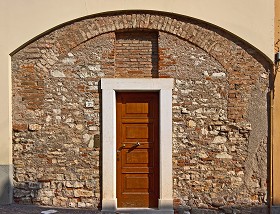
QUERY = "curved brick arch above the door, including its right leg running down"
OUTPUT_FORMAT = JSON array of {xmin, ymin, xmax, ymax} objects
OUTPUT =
[{"xmin": 36, "ymin": 12, "xmax": 271, "ymax": 121}]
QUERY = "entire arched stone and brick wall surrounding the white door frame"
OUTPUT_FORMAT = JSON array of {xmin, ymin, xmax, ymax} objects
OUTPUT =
[{"xmin": 12, "ymin": 13, "xmax": 270, "ymax": 212}]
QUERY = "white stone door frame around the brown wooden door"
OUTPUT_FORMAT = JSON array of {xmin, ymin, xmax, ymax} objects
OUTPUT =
[{"xmin": 101, "ymin": 78, "xmax": 173, "ymax": 213}]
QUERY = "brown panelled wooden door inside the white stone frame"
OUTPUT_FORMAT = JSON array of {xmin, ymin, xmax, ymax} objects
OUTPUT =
[{"xmin": 117, "ymin": 92, "xmax": 159, "ymax": 207}]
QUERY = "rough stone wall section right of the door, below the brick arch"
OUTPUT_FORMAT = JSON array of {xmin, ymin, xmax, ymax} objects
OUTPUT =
[{"xmin": 159, "ymin": 33, "xmax": 268, "ymax": 212}]
